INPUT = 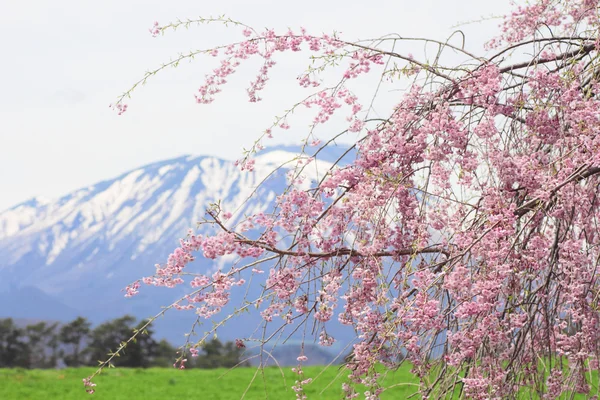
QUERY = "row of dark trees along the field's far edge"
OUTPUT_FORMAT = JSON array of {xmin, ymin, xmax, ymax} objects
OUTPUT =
[{"xmin": 0, "ymin": 315, "xmax": 242, "ymax": 368}]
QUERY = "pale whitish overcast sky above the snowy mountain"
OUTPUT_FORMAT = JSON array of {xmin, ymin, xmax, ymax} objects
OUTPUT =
[{"xmin": 0, "ymin": 0, "xmax": 509, "ymax": 211}]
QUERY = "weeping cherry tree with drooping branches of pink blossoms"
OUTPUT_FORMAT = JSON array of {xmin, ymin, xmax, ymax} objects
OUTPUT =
[{"xmin": 85, "ymin": 0, "xmax": 600, "ymax": 399}]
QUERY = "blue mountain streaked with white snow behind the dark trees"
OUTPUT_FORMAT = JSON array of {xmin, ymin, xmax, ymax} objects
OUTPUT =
[{"xmin": 0, "ymin": 148, "xmax": 352, "ymax": 346}]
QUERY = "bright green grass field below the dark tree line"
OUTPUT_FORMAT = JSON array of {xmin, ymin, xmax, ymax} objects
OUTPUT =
[{"xmin": 0, "ymin": 366, "xmax": 419, "ymax": 400}]
